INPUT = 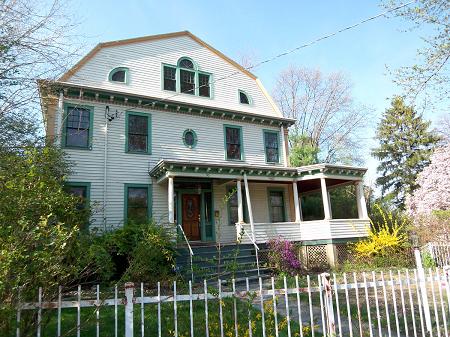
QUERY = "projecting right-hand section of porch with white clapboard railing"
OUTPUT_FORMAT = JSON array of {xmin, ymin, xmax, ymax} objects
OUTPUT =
[{"xmin": 236, "ymin": 164, "xmax": 370, "ymax": 244}]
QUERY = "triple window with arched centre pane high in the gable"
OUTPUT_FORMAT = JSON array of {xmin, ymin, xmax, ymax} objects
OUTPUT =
[{"xmin": 162, "ymin": 57, "xmax": 211, "ymax": 97}]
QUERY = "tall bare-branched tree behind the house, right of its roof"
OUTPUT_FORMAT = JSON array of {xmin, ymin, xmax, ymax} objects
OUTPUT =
[{"xmin": 274, "ymin": 66, "xmax": 368, "ymax": 164}]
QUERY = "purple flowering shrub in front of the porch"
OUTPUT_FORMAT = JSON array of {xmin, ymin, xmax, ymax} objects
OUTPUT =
[{"xmin": 267, "ymin": 237, "xmax": 301, "ymax": 275}]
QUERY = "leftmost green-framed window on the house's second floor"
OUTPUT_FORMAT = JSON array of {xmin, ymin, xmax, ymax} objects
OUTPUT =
[{"xmin": 63, "ymin": 106, "xmax": 93, "ymax": 149}]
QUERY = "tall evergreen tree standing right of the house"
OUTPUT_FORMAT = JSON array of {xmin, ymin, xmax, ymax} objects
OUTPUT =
[{"xmin": 372, "ymin": 96, "xmax": 439, "ymax": 209}]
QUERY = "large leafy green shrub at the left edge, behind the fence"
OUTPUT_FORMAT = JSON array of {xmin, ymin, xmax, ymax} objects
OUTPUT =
[{"xmin": 0, "ymin": 147, "xmax": 91, "ymax": 336}]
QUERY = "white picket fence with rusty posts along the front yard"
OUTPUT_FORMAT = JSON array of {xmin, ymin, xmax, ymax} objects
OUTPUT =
[{"xmin": 16, "ymin": 268, "xmax": 450, "ymax": 337}]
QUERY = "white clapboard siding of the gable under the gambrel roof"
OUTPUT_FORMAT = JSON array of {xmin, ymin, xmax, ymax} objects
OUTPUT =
[{"xmin": 67, "ymin": 36, "xmax": 281, "ymax": 117}]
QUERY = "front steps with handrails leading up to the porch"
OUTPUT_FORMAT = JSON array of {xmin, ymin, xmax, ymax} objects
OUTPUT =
[{"xmin": 176, "ymin": 244, "xmax": 271, "ymax": 284}]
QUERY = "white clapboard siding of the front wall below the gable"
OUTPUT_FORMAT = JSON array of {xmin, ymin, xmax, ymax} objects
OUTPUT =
[{"xmin": 65, "ymin": 100, "xmax": 284, "ymax": 228}]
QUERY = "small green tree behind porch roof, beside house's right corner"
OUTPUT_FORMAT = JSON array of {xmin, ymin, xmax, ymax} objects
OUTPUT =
[{"xmin": 289, "ymin": 135, "xmax": 319, "ymax": 166}]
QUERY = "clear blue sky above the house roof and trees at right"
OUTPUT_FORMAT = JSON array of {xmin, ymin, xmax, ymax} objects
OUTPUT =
[{"xmin": 70, "ymin": 0, "xmax": 437, "ymax": 182}]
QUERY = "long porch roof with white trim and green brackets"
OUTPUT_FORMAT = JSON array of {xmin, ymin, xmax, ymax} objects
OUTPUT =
[{"xmin": 149, "ymin": 159, "xmax": 367, "ymax": 182}]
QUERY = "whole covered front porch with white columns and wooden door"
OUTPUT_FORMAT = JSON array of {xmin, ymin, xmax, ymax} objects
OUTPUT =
[{"xmin": 150, "ymin": 160, "xmax": 369, "ymax": 244}]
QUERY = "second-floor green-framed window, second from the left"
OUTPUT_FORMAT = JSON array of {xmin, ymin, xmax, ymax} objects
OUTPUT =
[{"xmin": 125, "ymin": 112, "xmax": 151, "ymax": 154}]
